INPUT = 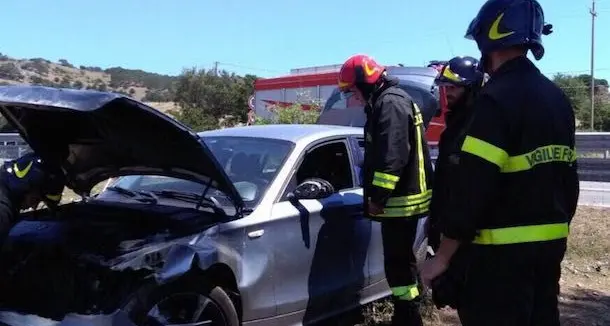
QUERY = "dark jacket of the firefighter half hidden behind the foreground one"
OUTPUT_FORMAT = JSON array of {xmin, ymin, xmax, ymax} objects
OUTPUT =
[{"xmin": 428, "ymin": 91, "xmax": 475, "ymax": 251}]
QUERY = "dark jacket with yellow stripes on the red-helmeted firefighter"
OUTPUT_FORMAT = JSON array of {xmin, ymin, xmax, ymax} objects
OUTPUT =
[{"xmin": 363, "ymin": 79, "xmax": 432, "ymax": 220}]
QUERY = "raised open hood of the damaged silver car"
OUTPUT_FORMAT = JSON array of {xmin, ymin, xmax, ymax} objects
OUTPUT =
[{"xmin": 0, "ymin": 86, "xmax": 243, "ymax": 207}]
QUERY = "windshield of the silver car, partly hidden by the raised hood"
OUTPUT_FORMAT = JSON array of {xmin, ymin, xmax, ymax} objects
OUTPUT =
[{"xmin": 100, "ymin": 136, "xmax": 294, "ymax": 210}]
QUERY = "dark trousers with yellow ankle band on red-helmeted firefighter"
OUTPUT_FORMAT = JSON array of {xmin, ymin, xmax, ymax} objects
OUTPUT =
[{"xmin": 381, "ymin": 217, "xmax": 422, "ymax": 326}]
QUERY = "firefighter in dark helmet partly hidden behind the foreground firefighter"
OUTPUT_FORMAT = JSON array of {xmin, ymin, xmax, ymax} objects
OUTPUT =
[{"xmin": 428, "ymin": 56, "xmax": 485, "ymax": 251}]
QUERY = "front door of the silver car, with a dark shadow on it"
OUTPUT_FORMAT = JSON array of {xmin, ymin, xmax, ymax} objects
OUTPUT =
[{"xmin": 272, "ymin": 138, "xmax": 370, "ymax": 322}]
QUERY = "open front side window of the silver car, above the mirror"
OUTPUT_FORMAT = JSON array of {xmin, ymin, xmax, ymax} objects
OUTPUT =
[{"xmin": 282, "ymin": 141, "xmax": 354, "ymax": 200}]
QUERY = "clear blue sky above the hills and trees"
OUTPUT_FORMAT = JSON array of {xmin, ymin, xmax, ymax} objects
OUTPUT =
[{"xmin": 0, "ymin": 0, "xmax": 610, "ymax": 78}]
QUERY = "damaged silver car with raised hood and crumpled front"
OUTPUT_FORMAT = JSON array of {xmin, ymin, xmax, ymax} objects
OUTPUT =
[{"xmin": 0, "ymin": 86, "xmax": 426, "ymax": 326}]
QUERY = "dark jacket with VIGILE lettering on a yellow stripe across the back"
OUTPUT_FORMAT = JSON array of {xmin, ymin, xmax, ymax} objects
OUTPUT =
[{"xmin": 440, "ymin": 57, "xmax": 579, "ymax": 245}]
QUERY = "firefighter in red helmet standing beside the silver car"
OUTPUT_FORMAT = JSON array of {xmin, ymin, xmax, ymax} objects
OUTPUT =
[{"xmin": 339, "ymin": 55, "xmax": 432, "ymax": 326}]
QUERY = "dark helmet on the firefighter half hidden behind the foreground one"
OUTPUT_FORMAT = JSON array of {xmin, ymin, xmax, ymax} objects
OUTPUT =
[{"xmin": 434, "ymin": 56, "xmax": 484, "ymax": 87}]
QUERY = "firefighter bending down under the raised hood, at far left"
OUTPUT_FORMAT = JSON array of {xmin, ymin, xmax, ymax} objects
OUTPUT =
[{"xmin": 0, "ymin": 153, "xmax": 64, "ymax": 244}]
